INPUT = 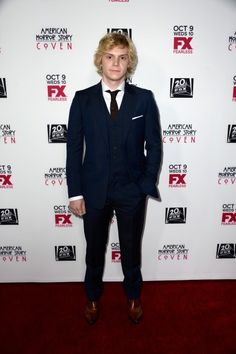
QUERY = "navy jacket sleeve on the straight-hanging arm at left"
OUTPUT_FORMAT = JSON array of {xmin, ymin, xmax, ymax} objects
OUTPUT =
[{"xmin": 66, "ymin": 92, "xmax": 84, "ymax": 198}]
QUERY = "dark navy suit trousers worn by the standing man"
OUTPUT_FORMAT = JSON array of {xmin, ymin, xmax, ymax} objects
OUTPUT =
[{"xmin": 83, "ymin": 182, "xmax": 146, "ymax": 301}]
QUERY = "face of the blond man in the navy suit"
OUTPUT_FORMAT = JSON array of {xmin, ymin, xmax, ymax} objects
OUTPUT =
[{"xmin": 102, "ymin": 47, "xmax": 129, "ymax": 86}]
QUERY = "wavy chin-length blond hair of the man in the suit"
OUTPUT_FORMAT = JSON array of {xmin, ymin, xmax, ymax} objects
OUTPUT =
[{"xmin": 94, "ymin": 32, "xmax": 138, "ymax": 78}]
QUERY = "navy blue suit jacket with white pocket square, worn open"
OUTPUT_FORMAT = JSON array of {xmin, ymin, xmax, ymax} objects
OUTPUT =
[{"xmin": 66, "ymin": 83, "xmax": 162, "ymax": 208}]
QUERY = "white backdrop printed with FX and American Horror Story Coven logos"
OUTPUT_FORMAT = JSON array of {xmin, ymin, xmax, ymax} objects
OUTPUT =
[{"xmin": 0, "ymin": 0, "xmax": 236, "ymax": 282}]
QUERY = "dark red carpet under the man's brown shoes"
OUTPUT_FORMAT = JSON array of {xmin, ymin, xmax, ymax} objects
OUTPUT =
[{"xmin": 0, "ymin": 281, "xmax": 236, "ymax": 354}]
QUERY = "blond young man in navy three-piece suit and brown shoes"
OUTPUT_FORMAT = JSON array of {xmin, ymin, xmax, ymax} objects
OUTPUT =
[{"xmin": 67, "ymin": 33, "xmax": 161, "ymax": 324}]
